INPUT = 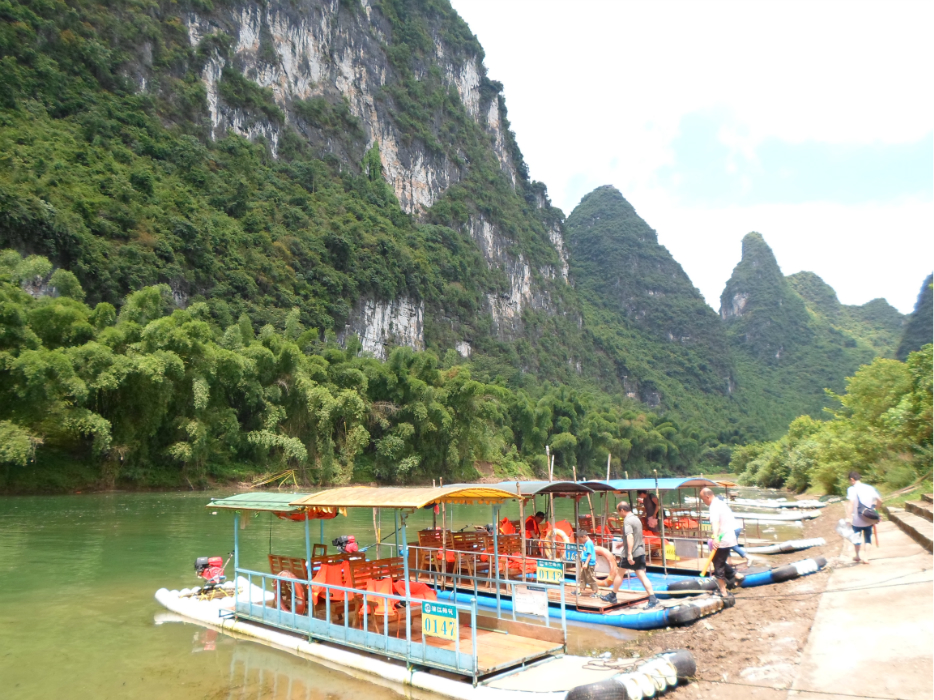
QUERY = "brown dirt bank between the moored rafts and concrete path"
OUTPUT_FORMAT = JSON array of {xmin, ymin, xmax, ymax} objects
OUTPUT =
[{"xmin": 614, "ymin": 503, "xmax": 848, "ymax": 700}]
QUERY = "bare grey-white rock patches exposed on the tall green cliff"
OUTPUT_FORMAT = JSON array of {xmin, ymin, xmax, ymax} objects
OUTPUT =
[{"xmin": 180, "ymin": 0, "xmax": 568, "ymax": 350}]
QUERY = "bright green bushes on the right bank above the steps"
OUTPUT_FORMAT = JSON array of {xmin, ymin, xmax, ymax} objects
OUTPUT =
[{"xmin": 730, "ymin": 344, "xmax": 932, "ymax": 493}]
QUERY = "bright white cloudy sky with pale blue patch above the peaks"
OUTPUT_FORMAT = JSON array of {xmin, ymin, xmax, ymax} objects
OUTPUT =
[{"xmin": 452, "ymin": 0, "xmax": 934, "ymax": 313}]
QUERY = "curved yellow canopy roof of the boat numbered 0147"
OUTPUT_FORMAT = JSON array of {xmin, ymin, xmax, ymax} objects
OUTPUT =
[{"xmin": 289, "ymin": 485, "xmax": 516, "ymax": 508}]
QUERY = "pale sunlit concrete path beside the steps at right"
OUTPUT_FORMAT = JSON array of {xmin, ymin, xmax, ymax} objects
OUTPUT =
[{"xmin": 788, "ymin": 521, "xmax": 934, "ymax": 700}]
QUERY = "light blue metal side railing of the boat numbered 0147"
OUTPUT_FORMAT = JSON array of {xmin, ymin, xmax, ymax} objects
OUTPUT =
[{"xmin": 234, "ymin": 567, "xmax": 480, "ymax": 684}]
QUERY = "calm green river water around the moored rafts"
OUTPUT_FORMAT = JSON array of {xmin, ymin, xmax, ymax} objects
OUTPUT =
[{"xmin": 0, "ymin": 492, "xmax": 637, "ymax": 700}]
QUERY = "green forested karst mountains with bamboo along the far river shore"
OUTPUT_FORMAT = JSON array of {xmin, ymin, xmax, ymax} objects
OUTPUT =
[{"xmin": 0, "ymin": 0, "xmax": 916, "ymax": 490}]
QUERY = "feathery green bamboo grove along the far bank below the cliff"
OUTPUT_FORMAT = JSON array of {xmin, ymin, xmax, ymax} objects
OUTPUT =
[{"xmin": 0, "ymin": 250, "xmax": 702, "ymax": 489}]
